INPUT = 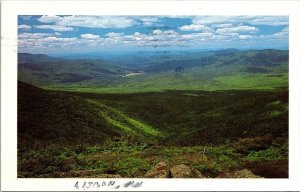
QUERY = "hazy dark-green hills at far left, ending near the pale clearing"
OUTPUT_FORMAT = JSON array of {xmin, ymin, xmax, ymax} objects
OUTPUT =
[{"xmin": 18, "ymin": 53, "xmax": 126, "ymax": 85}]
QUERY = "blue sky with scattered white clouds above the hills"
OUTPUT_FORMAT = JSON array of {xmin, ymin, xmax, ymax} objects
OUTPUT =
[{"xmin": 18, "ymin": 15, "xmax": 288, "ymax": 54}]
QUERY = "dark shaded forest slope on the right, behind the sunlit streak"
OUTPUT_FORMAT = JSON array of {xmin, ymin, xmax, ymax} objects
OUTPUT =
[{"xmin": 66, "ymin": 89, "xmax": 288, "ymax": 146}]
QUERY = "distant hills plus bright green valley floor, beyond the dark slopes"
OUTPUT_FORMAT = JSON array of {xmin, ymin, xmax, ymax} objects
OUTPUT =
[{"xmin": 18, "ymin": 49, "xmax": 289, "ymax": 92}]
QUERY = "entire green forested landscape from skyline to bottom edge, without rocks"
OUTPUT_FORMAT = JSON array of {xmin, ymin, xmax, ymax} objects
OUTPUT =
[{"xmin": 18, "ymin": 49, "xmax": 288, "ymax": 178}]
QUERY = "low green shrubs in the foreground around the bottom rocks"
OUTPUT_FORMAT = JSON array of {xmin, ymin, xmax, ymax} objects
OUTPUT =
[{"xmin": 18, "ymin": 135, "xmax": 288, "ymax": 178}]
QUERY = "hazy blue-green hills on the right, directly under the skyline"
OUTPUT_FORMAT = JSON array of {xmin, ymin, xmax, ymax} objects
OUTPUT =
[{"xmin": 143, "ymin": 49, "xmax": 289, "ymax": 72}]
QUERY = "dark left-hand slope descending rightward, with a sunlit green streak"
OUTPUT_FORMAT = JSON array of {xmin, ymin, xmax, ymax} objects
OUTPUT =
[{"xmin": 18, "ymin": 82, "xmax": 162, "ymax": 148}]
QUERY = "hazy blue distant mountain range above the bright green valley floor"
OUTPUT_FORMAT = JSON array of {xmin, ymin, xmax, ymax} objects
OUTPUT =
[{"xmin": 18, "ymin": 49, "xmax": 289, "ymax": 89}]
